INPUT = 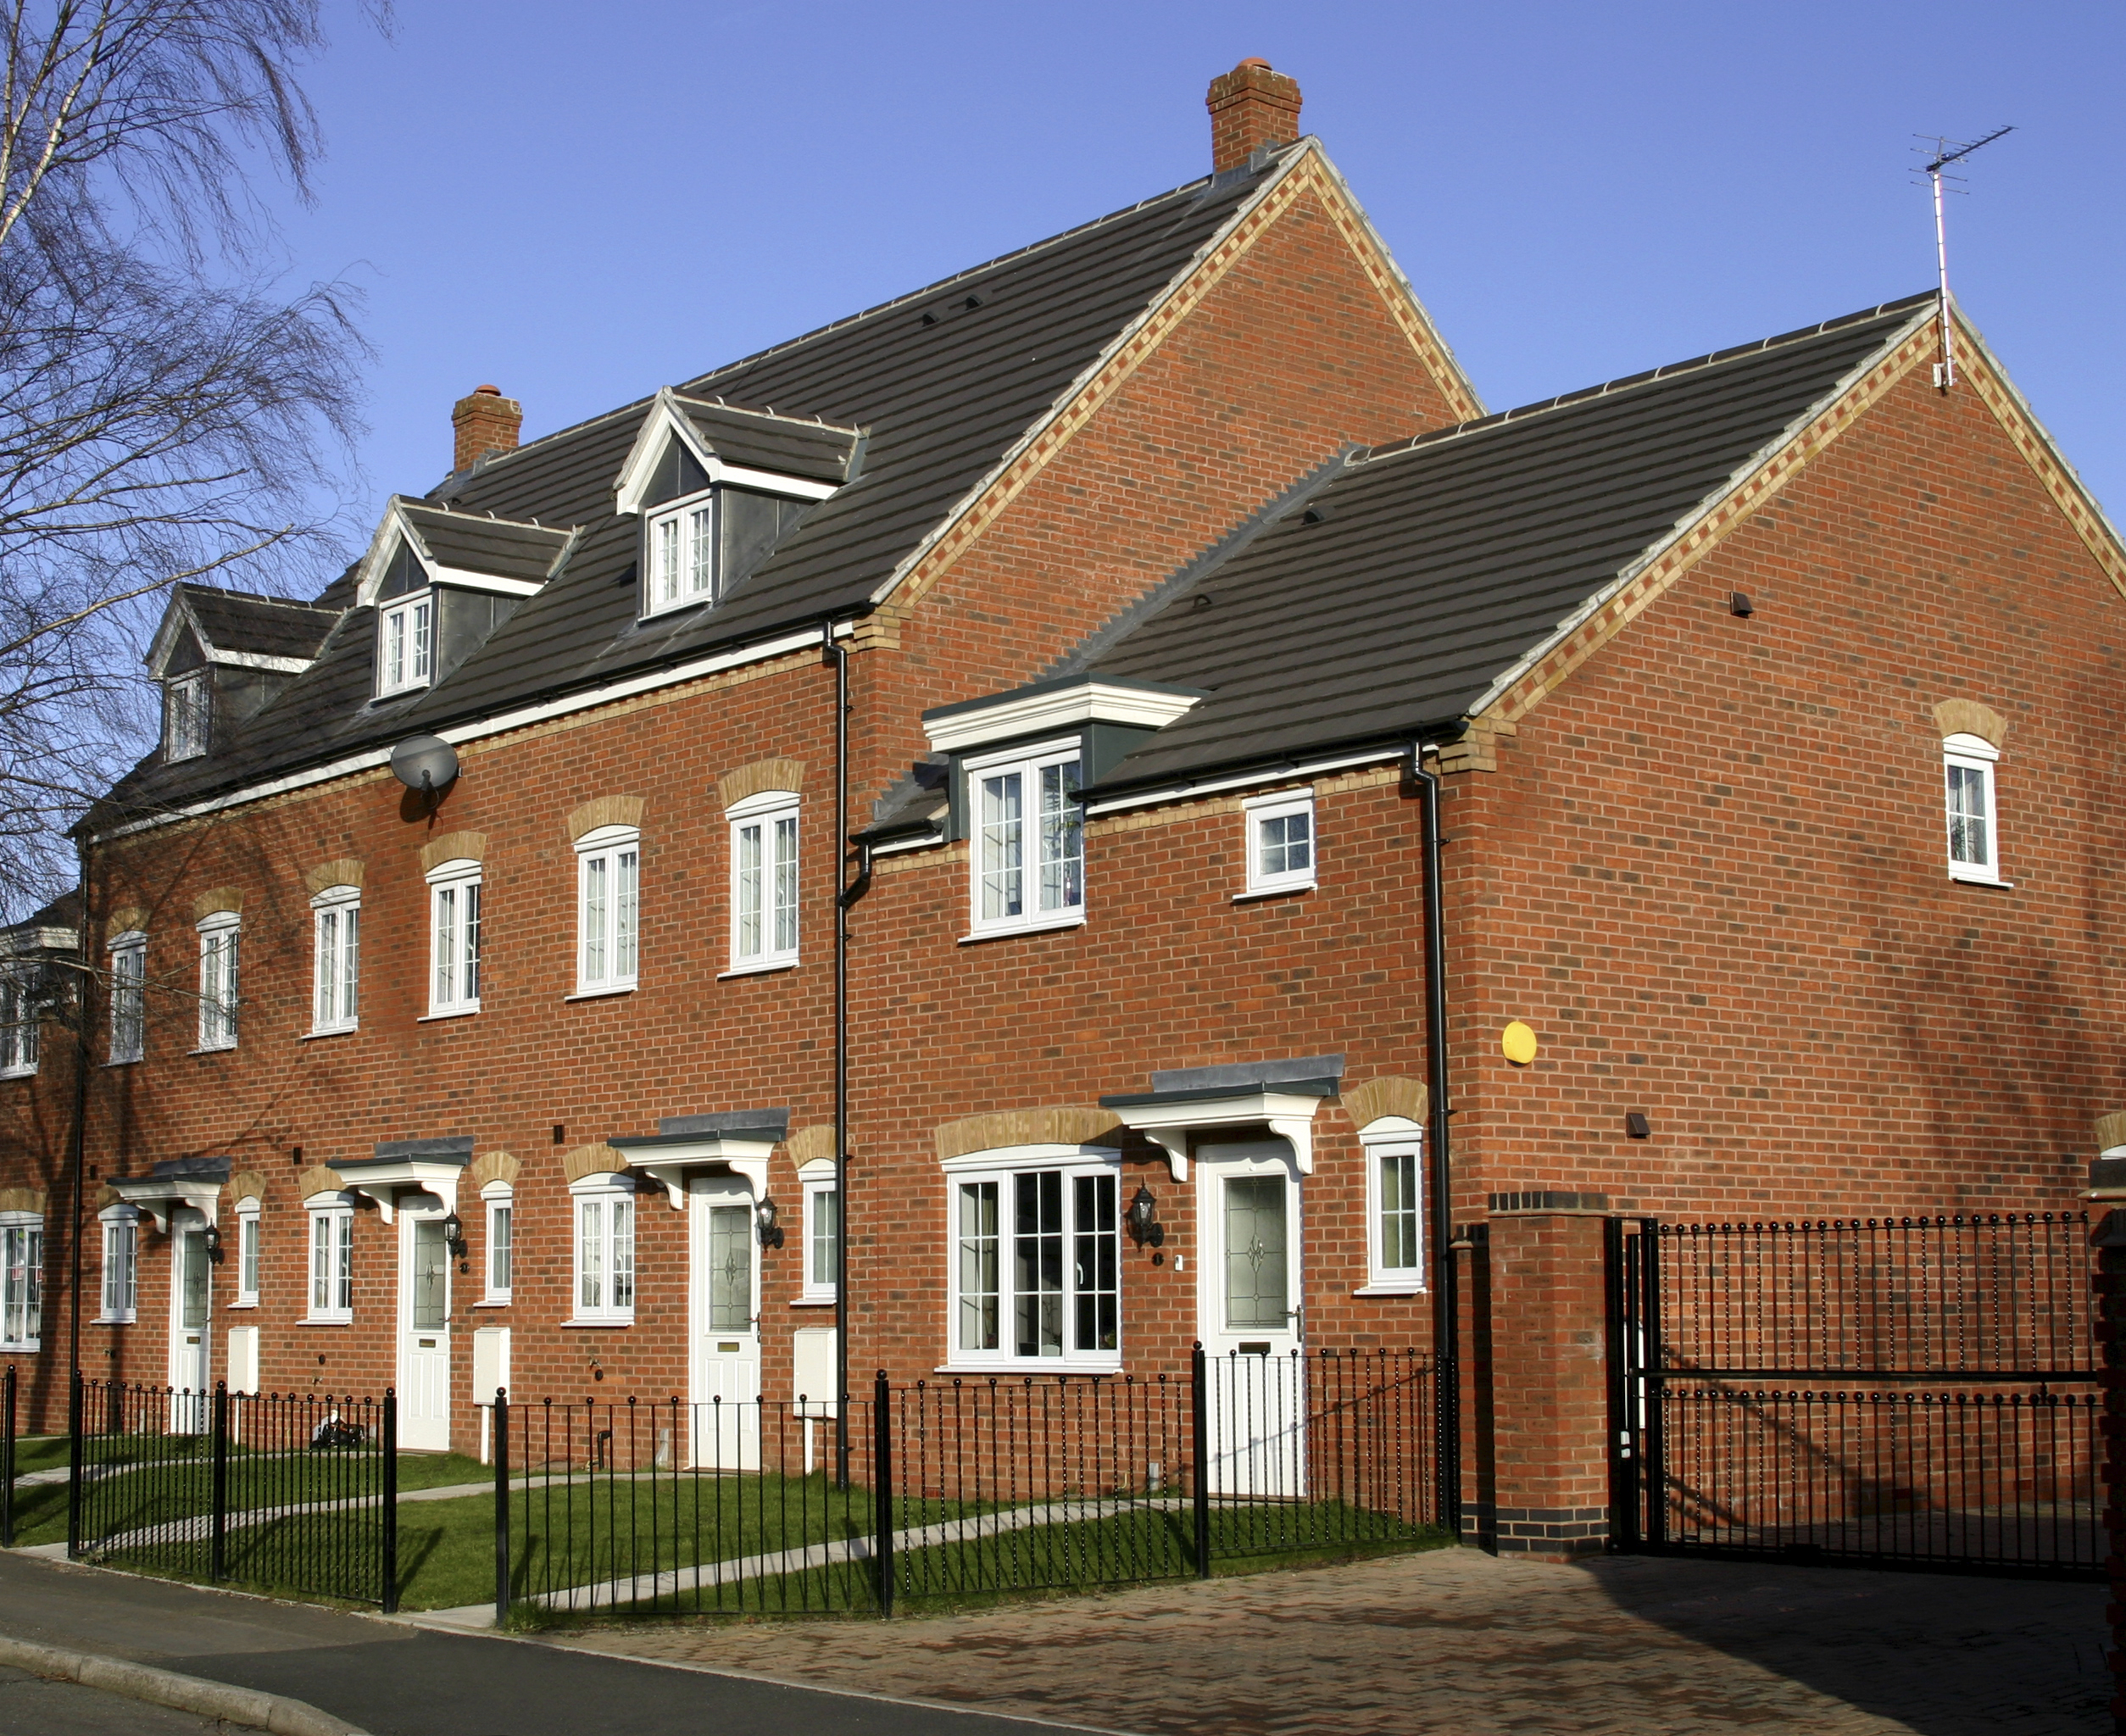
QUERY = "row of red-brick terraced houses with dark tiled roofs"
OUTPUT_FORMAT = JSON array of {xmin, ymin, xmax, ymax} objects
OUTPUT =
[{"xmin": 0, "ymin": 62, "xmax": 2126, "ymax": 1553}]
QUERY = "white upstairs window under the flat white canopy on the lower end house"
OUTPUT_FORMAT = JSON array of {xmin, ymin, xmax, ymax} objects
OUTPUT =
[{"xmin": 967, "ymin": 742, "xmax": 1084, "ymax": 935}]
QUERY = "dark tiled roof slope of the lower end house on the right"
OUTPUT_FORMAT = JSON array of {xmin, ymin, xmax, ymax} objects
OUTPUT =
[{"xmin": 1088, "ymin": 295, "xmax": 1930, "ymax": 793}]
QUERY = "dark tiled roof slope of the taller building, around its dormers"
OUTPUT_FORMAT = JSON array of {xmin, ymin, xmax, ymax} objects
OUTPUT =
[{"xmin": 113, "ymin": 153, "xmax": 1290, "ymax": 808}]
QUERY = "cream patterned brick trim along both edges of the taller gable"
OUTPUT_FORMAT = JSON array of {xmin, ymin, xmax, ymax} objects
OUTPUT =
[{"xmin": 880, "ymin": 140, "xmax": 1484, "ymax": 615}]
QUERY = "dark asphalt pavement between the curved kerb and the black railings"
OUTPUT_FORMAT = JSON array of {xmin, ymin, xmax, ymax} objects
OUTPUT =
[{"xmin": 0, "ymin": 1553, "xmax": 1114, "ymax": 1736}]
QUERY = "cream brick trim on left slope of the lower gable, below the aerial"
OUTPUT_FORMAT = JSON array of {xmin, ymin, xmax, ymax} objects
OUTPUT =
[{"xmin": 1482, "ymin": 323, "xmax": 1934, "ymax": 725}]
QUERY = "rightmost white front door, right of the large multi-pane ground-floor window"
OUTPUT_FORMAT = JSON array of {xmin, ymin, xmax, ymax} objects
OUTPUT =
[{"xmin": 1197, "ymin": 1139, "xmax": 1307, "ymax": 1500}]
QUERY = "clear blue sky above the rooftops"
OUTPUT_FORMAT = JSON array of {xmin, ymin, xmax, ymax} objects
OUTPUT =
[{"xmin": 274, "ymin": 0, "xmax": 2126, "ymax": 535}]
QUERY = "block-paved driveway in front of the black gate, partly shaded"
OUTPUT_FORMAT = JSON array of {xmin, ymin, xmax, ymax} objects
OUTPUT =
[{"xmin": 559, "ymin": 1549, "xmax": 2111, "ymax": 1736}]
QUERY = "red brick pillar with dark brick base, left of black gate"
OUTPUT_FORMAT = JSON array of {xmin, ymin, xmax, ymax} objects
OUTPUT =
[{"xmin": 1478, "ymin": 1192, "xmax": 1610, "ymax": 1561}]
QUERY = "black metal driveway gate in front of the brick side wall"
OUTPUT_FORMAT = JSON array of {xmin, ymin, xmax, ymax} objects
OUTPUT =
[{"xmin": 1607, "ymin": 1213, "xmax": 2105, "ymax": 1579}]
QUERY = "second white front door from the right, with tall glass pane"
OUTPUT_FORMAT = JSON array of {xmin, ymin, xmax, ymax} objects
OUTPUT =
[{"xmin": 689, "ymin": 1175, "xmax": 761, "ymax": 1471}]
